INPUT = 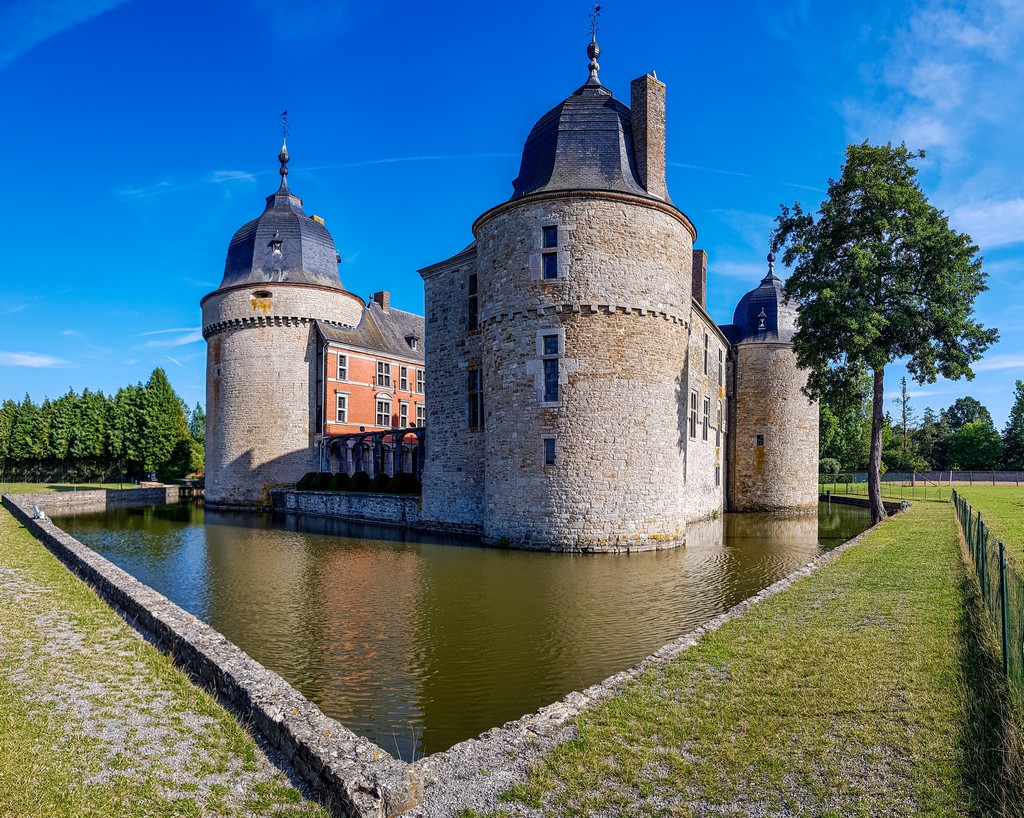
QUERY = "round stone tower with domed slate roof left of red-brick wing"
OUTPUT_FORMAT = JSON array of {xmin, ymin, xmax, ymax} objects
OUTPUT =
[{"xmin": 201, "ymin": 145, "xmax": 362, "ymax": 506}]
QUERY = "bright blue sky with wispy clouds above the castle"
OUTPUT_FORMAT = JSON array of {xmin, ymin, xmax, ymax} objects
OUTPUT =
[{"xmin": 0, "ymin": 0, "xmax": 1024, "ymax": 428}]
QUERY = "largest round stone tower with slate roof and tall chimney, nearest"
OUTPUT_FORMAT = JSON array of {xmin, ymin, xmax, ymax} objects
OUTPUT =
[{"xmin": 469, "ymin": 42, "xmax": 695, "ymax": 550}]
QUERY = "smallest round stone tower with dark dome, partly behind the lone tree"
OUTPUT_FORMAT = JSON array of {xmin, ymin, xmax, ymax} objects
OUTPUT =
[{"xmin": 728, "ymin": 254, "xmax": 818, "ymax": 512}]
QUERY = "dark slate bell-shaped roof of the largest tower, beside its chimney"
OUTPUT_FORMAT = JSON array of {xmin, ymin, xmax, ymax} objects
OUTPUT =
[{"xmin": 512, "ymin": 77, "xmax": 648, "ymax": 200}]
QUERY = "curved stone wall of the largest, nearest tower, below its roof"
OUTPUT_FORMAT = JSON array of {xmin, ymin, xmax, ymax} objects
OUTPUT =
[{"xmin": 474, "ymin": 193, "xmax": 692, "ymax": 550}]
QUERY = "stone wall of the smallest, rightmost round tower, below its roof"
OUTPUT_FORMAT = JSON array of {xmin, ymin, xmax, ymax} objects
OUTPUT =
[{"xmin": 729, "ymin": 342, "xmax": 818, "ymax": 512}]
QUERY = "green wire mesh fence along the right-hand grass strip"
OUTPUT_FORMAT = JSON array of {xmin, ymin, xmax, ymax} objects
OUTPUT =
[{"xmin": 951, "ymin": 488, "xmax": 1024, "ymax": 714}]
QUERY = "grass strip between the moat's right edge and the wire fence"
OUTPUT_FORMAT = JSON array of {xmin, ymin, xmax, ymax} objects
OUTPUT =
[{"xmin": 485, "ymin": 503, "xmax": 1024, "ymax": 816}]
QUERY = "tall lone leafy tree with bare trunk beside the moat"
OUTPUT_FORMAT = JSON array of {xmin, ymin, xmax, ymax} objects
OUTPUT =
[{"xmin": 772, "ymin": 142, "xmax": 998, "ymax": 521}]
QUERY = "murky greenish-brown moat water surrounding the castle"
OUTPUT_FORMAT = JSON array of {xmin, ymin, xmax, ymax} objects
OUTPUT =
[{"xmin": 59, "ymin": 504, "xmax": 869, "ymax": 760}]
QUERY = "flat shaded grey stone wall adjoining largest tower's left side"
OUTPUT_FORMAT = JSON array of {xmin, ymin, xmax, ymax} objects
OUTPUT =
[{"xmin": 422, "ymin": 253, "xmax": 489, "ymax": 525}]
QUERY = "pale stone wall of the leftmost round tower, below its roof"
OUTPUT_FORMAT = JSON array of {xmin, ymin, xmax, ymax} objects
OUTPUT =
[{"xmin": 203, "ymin": 284, "xmax": 361, "ymax": 506}]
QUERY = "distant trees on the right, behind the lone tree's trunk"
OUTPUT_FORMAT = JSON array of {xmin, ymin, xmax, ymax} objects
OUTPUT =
[{"xmin": 819, "ymin": 378, "xmax": 1024, "ymax": 472}]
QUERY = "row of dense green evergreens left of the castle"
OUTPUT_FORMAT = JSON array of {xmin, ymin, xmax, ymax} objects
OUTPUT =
[{"xmin": 0, "ymin": 369, "xmax": 206, "ymax": 482}]
